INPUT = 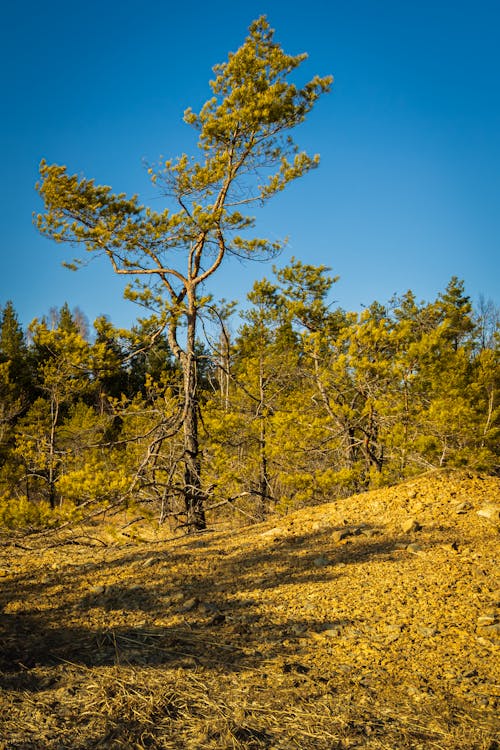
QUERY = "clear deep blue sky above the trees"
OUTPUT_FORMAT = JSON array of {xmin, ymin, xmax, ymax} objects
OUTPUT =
[{"xmin": 0, "ymin": 0, "xmax": 500, "ymax": 326}]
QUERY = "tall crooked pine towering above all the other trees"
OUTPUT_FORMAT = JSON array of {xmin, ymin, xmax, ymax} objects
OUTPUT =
[{"xmin": 38, "ymin": 17, "xmax": 332, "ymax": 529}]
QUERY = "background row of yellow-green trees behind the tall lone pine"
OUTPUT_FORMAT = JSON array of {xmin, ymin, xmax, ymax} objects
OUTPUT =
[{"xmin": 0, "ymin": 259, "xmax": 500, "ymax": 527}]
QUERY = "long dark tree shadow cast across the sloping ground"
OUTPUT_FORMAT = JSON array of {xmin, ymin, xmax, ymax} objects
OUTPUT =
[{"xmin": 0, "ymin": 529, "xmax": 442, "ymax": 691}]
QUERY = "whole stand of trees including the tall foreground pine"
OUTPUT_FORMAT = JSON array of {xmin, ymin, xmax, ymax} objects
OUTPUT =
[{"xmin": 0, "ymin": 16, "xmax": 499, "ymax": 531}]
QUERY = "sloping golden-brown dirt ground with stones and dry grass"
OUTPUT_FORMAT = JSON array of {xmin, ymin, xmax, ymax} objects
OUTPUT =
[{"xmin": 0, "ymin": 472, "xmax": 500, "ymax": 750}]
